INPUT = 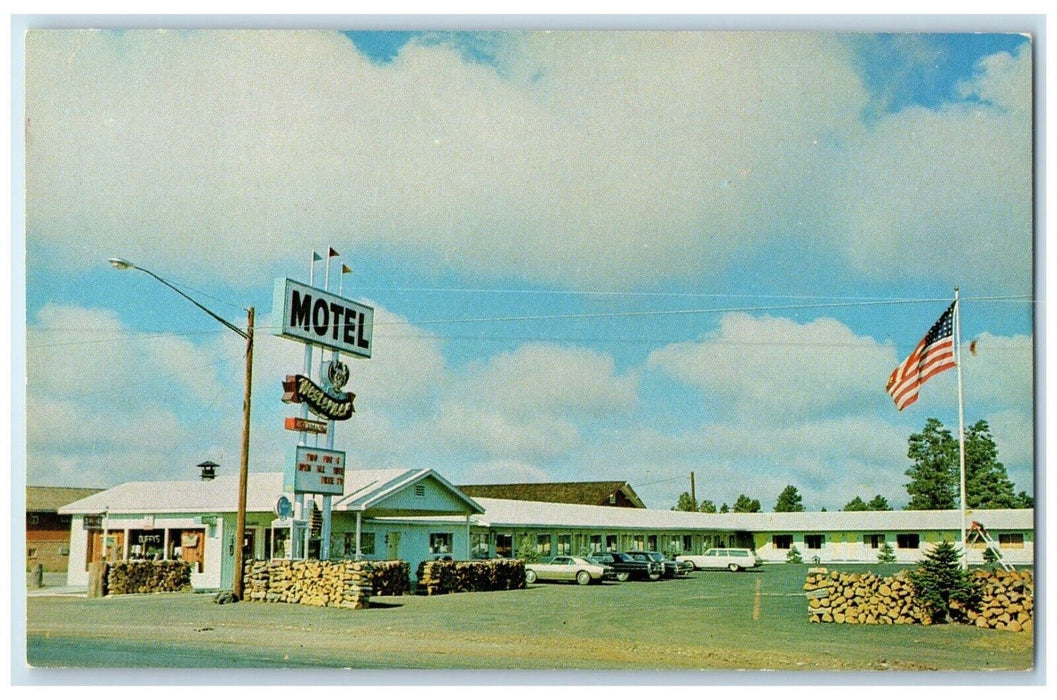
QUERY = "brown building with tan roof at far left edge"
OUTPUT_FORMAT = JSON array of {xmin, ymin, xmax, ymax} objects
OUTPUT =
[{"xmin": 25, "ymin": 486, "xmax": 103, "ymax": 572}]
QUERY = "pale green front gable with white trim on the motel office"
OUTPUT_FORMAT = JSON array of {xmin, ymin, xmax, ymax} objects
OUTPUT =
[{"xmin": 333, "ymin": 469, "xmax": 484, "ymax": 517}]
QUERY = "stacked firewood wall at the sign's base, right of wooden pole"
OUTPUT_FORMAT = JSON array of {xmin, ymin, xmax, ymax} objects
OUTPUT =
[{"xmin": 243, "ymin": 559, "xmax": 373, "ymax": 609}]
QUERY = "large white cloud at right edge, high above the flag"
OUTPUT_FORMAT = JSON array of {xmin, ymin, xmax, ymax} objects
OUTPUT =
[{"xmin": 824, "ymin": 41, "xmax": 1033, "ymax": 294}]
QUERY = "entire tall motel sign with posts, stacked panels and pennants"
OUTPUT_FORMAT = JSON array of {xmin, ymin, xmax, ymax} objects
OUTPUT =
[{"xmin": 271, "ymin": 248, "xmax": 374, "ymax": 560}]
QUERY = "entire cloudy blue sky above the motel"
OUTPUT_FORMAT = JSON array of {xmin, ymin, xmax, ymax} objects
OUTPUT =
[{"xmin": 18, "ymin": 31, "xmax": 1035, "ymax": 510}]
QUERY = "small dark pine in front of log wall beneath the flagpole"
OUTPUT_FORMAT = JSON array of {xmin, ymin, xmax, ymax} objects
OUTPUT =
[{"xmin": 907, "ymin": 540, "xmax": 982, "ymax": 623}]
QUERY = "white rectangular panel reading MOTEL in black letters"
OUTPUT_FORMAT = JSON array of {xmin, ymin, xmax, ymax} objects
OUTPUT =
[{"xmin": 272, "ymin": 279, "xmax": 374, "ymax": 357}]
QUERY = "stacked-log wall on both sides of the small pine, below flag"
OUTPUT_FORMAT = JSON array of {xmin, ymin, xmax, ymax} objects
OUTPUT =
[{"xmin": 803, "ymin": 569, "xmax": 1035, "ymax": 631}]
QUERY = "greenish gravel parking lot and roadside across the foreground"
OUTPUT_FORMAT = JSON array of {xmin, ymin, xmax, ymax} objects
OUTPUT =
[{"xmin": 26, "ymin": 565, "xmax": 1034, "ymax": 679}]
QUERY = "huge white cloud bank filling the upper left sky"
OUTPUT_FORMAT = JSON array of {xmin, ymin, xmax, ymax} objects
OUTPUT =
[{"xmin": 26, "ymin": 32, "xmax": 865, "ymax": 288}]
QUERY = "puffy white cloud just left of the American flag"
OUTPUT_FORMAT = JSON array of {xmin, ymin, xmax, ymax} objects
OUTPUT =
[{"xmin": 648, "ymin": 313, "xmax": 896, "ymax": 425}]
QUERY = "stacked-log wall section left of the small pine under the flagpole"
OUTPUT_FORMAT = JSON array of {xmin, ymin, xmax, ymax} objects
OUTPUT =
[{"xmin": 803, "ymin": 569, "xmax": 929, "ymax": 625}]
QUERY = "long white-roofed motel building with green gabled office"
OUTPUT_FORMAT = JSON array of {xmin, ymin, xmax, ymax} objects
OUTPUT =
[{"xmin": 59, "ymin": 468, "xmax": 1035, "ymax": 590}]
